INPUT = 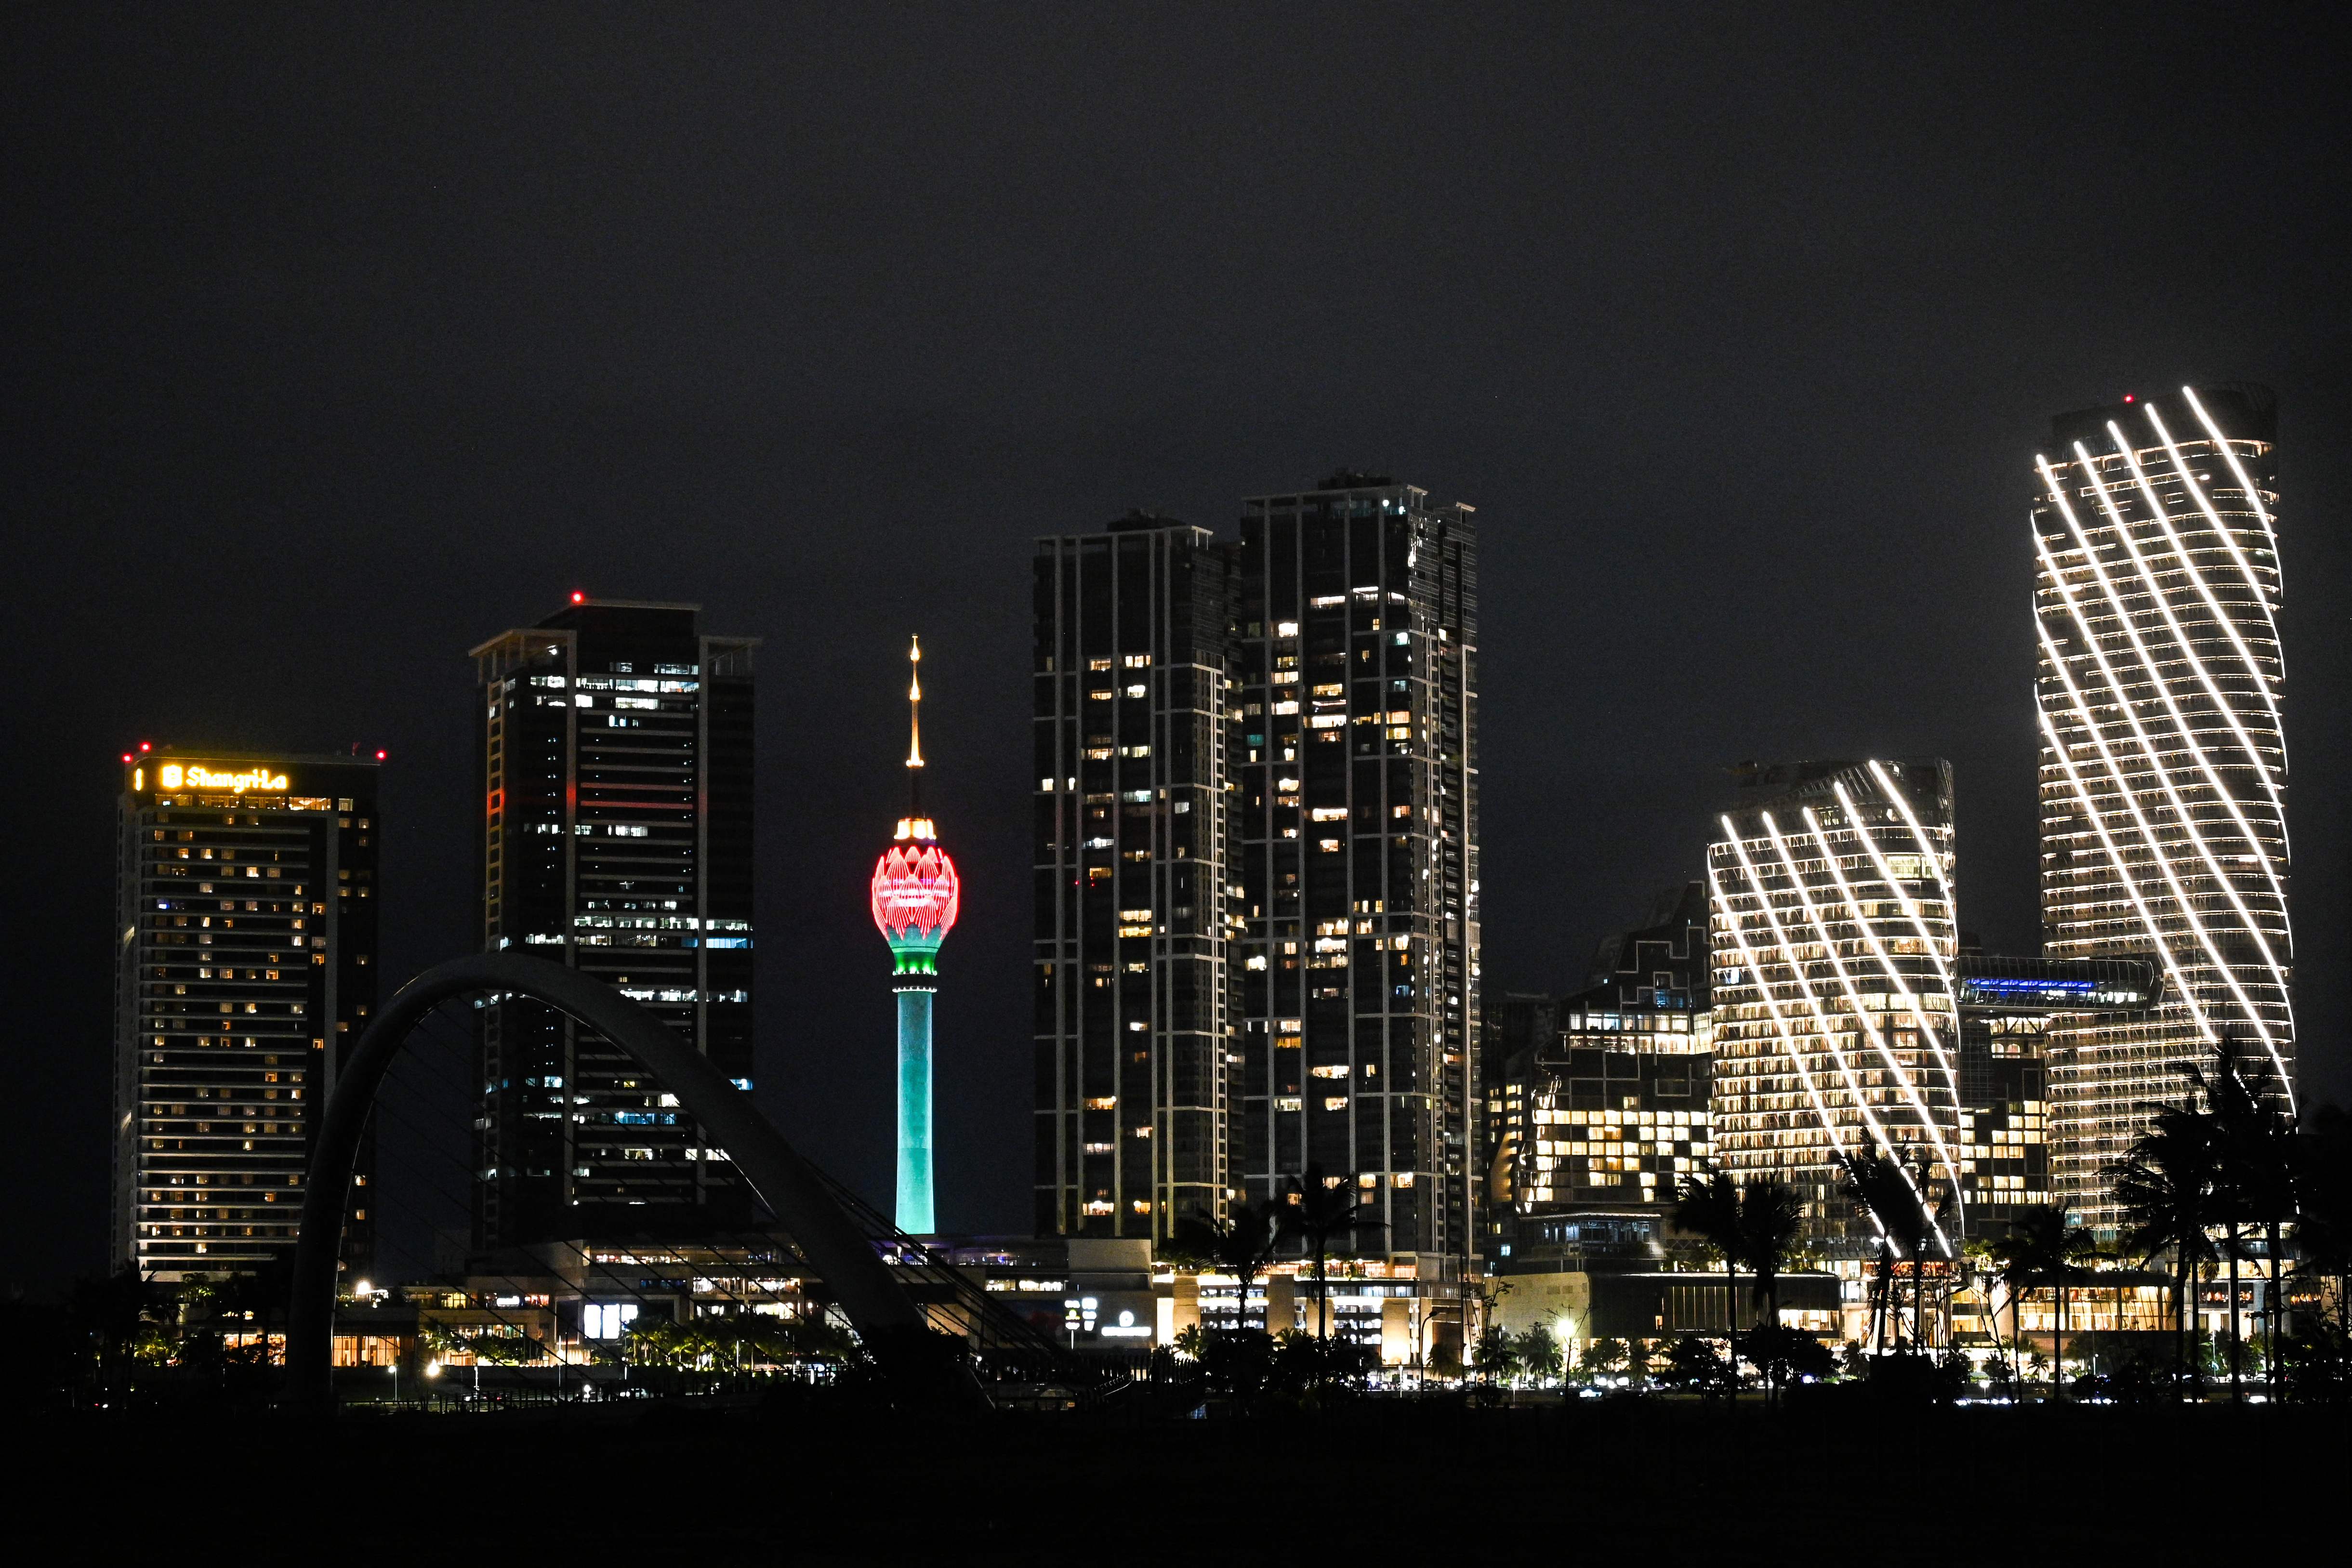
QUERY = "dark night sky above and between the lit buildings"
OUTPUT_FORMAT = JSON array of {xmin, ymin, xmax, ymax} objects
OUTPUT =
[{"xmin": 0, "ymin": 5, "xmax": 2352, "ymax": 1281}]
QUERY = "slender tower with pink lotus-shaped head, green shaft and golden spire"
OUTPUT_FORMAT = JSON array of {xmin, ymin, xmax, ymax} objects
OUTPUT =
[{"xmin": 872, "ymin": 637, "xmax": 957, "ymax": 1237}]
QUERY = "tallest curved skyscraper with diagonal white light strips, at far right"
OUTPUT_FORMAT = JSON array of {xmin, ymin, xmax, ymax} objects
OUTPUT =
[{"xmin": 2032, "ymin": 385, "xmax": 2296, "ymax": 1229}]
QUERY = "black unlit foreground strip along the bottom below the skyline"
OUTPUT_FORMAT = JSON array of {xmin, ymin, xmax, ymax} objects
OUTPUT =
[{"xmin": 10, "ymin": 1401, "xmax": 2352, "ymax": 1566}]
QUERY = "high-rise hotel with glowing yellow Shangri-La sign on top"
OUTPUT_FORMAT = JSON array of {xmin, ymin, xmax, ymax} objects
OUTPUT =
[{"xmin": 113, "ymin": 750, "xmax": 381, "ymax": 1281}]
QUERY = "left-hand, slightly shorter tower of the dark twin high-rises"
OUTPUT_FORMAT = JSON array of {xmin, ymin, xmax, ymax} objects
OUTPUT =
[{"xmin": 1032, "ymin": 513, "xmax": 1237, "ymax": 1239}]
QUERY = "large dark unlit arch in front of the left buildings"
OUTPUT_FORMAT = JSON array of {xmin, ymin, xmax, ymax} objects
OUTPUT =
[{"xmin": 287, "ymin": 952, "xmax": 964, "ymax": 1408}]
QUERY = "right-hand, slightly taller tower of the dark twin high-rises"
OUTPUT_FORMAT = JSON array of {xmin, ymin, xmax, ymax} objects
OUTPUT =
[{"xmin": 1230, "ymin": 473, "xmax": 1484, "ymax": 1279}]
